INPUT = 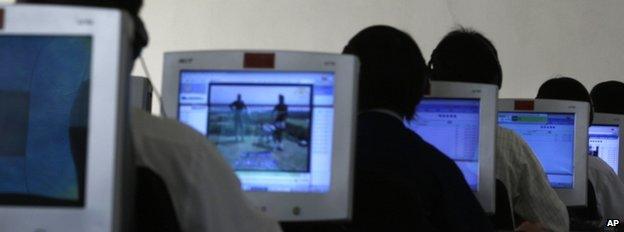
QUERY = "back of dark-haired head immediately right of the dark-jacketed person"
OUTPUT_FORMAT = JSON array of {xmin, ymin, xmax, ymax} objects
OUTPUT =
[{"xmin": 429, "ymin": 28, "xmax": 503, "ymax": 88}]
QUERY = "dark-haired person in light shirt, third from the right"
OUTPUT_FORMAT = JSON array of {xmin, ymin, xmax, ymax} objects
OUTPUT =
[{"xmin": 429, "ymin": 28, "xmax": 569, "ymax": 231}]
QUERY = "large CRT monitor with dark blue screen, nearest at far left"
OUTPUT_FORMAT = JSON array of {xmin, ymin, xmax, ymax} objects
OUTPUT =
[{"xmin": 0, "ymin": 5, "xmax": 132, "ymax": 232}]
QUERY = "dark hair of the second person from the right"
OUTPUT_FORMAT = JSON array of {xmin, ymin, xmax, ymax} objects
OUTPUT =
[{"xmin": 535, "ymin": 77, "xmax": 594, "ymax": 122}]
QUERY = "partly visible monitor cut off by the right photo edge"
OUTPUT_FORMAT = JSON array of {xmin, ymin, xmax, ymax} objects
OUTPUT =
[{"xmin": 589, "ymin": 113, "xmax": 624, "ymax": 181}]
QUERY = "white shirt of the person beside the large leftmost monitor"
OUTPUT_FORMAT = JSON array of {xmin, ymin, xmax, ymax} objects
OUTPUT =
[{"xmin": 131, "ymin": 110, "xmax": 281, "ymax": 232}]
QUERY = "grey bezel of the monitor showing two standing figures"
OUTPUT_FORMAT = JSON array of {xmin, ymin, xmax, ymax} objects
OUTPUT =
[{"xmin": 162, "ymin": 50, "xmax": 358, "ymax": 221}]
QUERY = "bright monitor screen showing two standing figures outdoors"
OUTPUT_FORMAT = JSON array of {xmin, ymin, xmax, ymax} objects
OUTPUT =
[{"xmin": 178, "ymin": 71, "xmax": 334, "ymax": 193}]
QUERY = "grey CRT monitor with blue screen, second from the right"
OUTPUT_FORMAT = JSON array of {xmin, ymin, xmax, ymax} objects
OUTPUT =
[{"xmin": 498, "ymin": 99, "xmax": 589, "ymax": 206}]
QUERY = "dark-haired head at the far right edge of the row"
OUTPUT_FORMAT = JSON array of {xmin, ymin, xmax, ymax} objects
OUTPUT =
[{"xmin": 590, "ymin": 81, "xmax": 624, "ymax": 114}]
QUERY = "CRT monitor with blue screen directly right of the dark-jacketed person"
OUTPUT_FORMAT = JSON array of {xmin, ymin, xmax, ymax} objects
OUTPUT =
[{"xmin": 406, "ymin": 81, "xmax": 498, "ymax": 213}]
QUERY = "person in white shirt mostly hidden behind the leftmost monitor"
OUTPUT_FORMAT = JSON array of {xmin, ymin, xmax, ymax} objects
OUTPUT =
[{"xmin": 17, "ymin": 0, "xmax": 281, "ymax": 232}]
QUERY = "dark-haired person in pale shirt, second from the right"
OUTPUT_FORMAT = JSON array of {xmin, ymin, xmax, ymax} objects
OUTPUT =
[{"xmin": 536, "ymin": 77, "xmax": 624, "ymax": 227}]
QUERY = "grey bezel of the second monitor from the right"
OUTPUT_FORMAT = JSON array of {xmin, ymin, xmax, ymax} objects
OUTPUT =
[{"xmin": 496, "ymin": 99, "xmax": 590, "ymax": 206}]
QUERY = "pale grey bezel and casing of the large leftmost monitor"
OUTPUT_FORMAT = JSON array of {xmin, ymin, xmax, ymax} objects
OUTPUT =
[{"xmin": 0, "ymin": 4, "xmax": 132, "ymax": 232}]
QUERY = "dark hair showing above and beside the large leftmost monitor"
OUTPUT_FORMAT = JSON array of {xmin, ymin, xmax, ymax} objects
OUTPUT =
[{"xmin": 17, "ymin": 0, "xmax": 149, "ymax": 59}]
